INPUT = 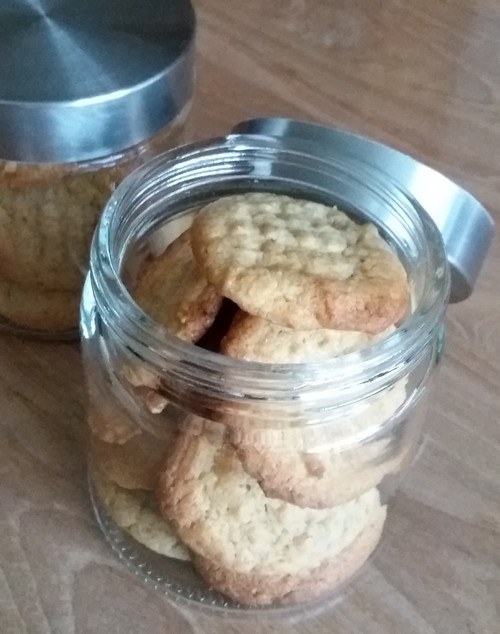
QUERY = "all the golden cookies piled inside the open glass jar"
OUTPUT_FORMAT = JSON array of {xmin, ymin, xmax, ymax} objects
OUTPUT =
[{"xmin": 89, "ymin": 193, "xmax": 409, "ymax": 605}]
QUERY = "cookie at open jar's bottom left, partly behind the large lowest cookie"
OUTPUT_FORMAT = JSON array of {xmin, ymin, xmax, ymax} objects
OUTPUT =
[{"xmin": 92, "ymin": 471, "xmax": 190, "ymax": 561}]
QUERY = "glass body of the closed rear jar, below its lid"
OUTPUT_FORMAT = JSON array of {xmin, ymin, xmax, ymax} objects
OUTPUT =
[{"xmin": 0, "ymin": 105, "xmax": 190, "ymax": 339}]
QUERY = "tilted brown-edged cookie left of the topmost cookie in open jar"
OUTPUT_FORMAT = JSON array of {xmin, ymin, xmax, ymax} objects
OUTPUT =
[{"xmin": 132, "ymin": 231, "xmax": 222, "ymax": 342}]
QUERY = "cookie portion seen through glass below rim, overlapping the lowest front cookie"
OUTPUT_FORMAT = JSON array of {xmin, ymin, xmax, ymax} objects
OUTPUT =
[{"xmin": 227, "ymin": 382, "xmax": 407, "ymax": 509}]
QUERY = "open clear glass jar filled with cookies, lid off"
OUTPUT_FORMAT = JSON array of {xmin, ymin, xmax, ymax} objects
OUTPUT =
[{"xmin": 81, "ymin": 135, "xmax": 449, "ymax": 610}]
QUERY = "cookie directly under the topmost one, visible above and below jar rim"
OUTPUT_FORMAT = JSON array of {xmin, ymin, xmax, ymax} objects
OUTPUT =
[{"xmin": 221, "ymin": 312, "xmax": 406, "ymax": 508}]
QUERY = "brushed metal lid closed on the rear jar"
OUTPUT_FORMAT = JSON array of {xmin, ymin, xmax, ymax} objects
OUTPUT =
[{"xmin": 0, "ymin": 0, "xmax": 195, "ymax": 163}]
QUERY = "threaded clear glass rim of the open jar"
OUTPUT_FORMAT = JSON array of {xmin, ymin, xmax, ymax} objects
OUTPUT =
[{"xmin": 89, "ymin": 134, "xmax": 450, "ymax": 398}]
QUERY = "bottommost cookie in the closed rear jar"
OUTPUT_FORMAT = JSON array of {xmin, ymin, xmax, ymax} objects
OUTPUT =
[{"xmin": 0, "ymin": 278, "xmax": 80, "ymax": 333}]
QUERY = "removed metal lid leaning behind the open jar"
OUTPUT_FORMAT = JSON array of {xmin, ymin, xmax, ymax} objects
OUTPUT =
[{"xmin": 233, "ymin": 118, "xmax": 494, "ymax": 302}]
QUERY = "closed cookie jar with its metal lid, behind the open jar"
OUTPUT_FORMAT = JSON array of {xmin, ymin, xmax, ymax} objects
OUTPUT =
[{"xmin": 0, "ymin": 0, "xmax": 195, "ymax": 338}]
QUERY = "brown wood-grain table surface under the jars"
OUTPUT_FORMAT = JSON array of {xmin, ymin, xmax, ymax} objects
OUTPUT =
[{"xmin": 0, "ymin": 0, "xmax": 500, "ymax": 634}]
